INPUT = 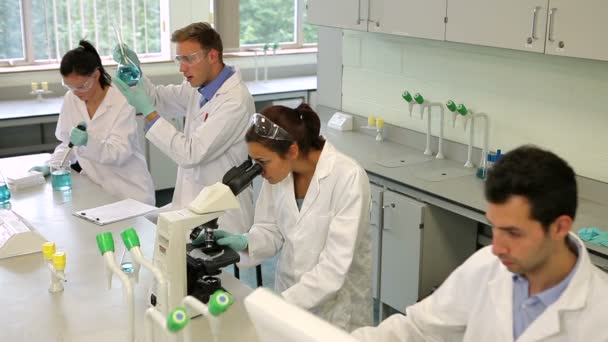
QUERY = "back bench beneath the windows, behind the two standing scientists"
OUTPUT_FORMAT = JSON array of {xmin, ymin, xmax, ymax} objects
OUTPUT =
[{"xmin": 0, "ymin": 76, "xmax": 317, "ymax": 190}]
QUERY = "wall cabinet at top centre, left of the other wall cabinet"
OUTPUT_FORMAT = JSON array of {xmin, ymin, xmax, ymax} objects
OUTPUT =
[{"xmin": 307, "ymin": 0, "xmax": 446, "ymax": 40}]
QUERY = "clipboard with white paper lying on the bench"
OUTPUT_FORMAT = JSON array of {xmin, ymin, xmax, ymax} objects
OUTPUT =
[{"xmin": 73, "ymin": 198, "xmax": 158, "ymax": 226}]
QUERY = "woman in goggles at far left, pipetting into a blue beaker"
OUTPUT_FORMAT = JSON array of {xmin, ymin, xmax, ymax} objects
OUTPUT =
[{"xmin": 32, "ymin": 40, "xmax": 155, "ymax": 204}]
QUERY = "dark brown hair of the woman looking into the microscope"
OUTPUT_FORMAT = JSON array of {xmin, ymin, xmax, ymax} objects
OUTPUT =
[{"xmin": 245, "ymin": 103, "xmax": 325, "ymax": 157}]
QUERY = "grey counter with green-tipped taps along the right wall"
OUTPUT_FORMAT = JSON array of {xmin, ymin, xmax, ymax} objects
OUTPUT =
[{"xmin": 317, "ymin": 106, "xmax": 608, "ymax": 262}]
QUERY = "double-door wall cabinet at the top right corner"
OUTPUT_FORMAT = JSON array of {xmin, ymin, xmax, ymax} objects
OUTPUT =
[{"xmin": 445, "ymin": 0, "xmax": 608, "ymax": 60}]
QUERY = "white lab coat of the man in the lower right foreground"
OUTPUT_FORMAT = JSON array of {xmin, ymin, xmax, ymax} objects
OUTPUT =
[{"xmin": 353, "ymin": 233, "xmax": 608, "ymax": 342}]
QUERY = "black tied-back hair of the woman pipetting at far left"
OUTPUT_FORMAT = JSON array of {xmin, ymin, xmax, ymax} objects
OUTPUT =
[{"xmin": 59, "ymin": 39, "xmax": 111, "ymax": 88}]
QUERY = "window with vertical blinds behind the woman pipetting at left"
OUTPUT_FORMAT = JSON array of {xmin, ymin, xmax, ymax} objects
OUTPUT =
[{"xmin": 0, "ymin": 0, "xmax": 169, "ymax": 66}]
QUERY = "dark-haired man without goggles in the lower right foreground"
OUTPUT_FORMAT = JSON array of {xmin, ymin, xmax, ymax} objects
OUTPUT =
[{"xmin": 353, "ymin": 146, "xmax": 608, "ymax": 342}]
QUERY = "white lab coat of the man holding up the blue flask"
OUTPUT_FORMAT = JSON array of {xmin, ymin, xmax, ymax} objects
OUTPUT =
[{"xmin": 145, "ymin": 68, "xmax": 255, "ymax": 233}]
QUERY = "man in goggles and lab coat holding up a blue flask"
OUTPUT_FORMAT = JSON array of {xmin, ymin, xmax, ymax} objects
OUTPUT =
[{"xmin": 113, "ymin": 23, "xmax": 255, "ymax": 232}]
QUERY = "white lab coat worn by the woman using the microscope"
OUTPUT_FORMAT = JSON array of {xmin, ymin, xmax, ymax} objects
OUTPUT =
[{"xmin": 244, "ymin": 141, "xmax": 372, "ymax": 331}]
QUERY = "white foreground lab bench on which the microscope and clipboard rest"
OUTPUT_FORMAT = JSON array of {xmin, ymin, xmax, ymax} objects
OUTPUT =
[{"xmin": 0, "ymin": 155, "xmax": 257, "ymax": 342}]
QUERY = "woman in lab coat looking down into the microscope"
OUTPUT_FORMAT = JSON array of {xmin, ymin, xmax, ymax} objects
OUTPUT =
[{"xmin": 211, "ymin": 104, "xmax": 372, "ymax": 331}]
